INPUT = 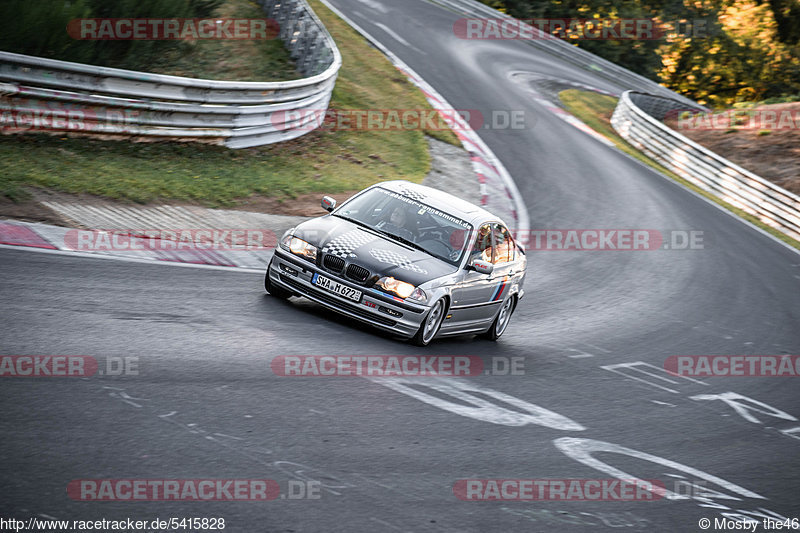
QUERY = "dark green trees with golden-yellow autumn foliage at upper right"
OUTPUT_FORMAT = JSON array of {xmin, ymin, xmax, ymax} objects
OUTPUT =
[{"xmin": 484, "ymin": 0, "xmax": 800, "ymax": 106}]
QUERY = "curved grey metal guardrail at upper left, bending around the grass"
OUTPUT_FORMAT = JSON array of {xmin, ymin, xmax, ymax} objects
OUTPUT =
[{"xmin": 0, "ymin": 0, "xmax": 342, "ymax": 148}]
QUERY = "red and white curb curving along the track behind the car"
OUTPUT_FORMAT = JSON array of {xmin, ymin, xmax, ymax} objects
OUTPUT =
[{"xmin": 320, "ymin": 0, "xmax": 530, "ymax": 233}]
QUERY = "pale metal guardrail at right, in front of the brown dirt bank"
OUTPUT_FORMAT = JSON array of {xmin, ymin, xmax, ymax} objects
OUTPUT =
[{"xmin": 611, "ymin": 91, "xmax": 800, "ymax": 240}]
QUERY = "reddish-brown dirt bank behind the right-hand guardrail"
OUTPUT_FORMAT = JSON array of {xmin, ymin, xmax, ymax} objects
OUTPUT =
[{"xmin": 664, "ymin": 102, "xmax": 800, "ymax": 194}]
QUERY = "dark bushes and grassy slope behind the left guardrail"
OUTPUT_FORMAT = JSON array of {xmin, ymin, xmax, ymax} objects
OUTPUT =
[{"xmin": 0, "ymin": 0, "xmax": 300, "ymax": 81}]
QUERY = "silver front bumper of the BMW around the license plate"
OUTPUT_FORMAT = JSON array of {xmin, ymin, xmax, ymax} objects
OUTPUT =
[{"xmin": 267, "ymin": 248, "xmax": 429, "ymax": 338}]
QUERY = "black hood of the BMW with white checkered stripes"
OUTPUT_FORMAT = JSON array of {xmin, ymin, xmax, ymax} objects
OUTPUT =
[{"xmin": 294, "ymin": 215, "xmax": 458, "ymax": 286}]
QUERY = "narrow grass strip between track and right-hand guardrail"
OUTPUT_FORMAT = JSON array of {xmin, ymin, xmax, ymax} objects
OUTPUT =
[{"xmin": 559, "ymin": 89, "xmax": 800, "ymax": 249}]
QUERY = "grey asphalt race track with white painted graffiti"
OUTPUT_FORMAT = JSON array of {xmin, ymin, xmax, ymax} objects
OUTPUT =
[{"xmin": 0, "ymin": 0, "xmax": 800, "ymax": 532}]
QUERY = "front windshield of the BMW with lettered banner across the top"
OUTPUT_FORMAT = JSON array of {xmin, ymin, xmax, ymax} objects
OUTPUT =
[{"xmin": 333, "ymin": 187, "xmax": 472, "ymax": 266}]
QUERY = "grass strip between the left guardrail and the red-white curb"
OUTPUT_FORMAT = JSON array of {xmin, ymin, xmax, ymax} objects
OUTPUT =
[{"xmin": 0, "ymin": 0, "xmax": 457, "ymax": 207}]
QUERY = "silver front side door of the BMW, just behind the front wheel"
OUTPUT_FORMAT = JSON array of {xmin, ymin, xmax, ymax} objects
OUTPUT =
[{"xmin": 446, "ymin": 223, "xmax": 502, "ymax": 329}]
